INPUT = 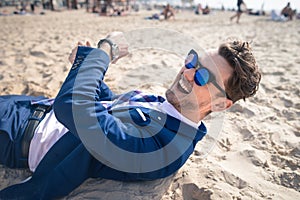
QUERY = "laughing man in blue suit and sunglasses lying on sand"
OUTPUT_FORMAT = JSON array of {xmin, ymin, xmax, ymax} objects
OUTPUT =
[{"xmin": 0, "ymin": 32, "xmax": 261, "ymax": 199}]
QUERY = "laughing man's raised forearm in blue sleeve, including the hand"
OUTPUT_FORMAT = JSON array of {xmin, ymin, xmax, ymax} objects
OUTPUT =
[{"xmin": 53, "ymin": 32, "xmax": 128, "ymax": 138}]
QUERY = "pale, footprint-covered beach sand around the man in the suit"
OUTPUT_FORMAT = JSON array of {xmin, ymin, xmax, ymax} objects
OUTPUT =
[{"xmin": 0, "ymin": 7, "xmax": 300, "ymax": 200}]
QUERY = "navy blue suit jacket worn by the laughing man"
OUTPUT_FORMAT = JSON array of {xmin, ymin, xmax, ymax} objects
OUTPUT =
[{"xmin": 0, "ymin": 47, "xmax": 206, "ymax": 199}]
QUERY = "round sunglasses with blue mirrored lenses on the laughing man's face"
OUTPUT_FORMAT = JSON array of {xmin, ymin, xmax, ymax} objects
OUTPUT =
[{"xmin": 185, "ymin": 49, "xmax": 232, "ymax": 100}]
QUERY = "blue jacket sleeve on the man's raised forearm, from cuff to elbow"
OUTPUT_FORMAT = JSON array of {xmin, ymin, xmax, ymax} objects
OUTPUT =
[{"xmin": 53, "ymin": 46, "xmax": 110, "ymax": 134}]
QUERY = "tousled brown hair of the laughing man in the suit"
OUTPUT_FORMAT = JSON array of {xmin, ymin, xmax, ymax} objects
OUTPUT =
[{"xmin": 218, "ymin": 41, "xmax": 261, "ymax": 102}]
